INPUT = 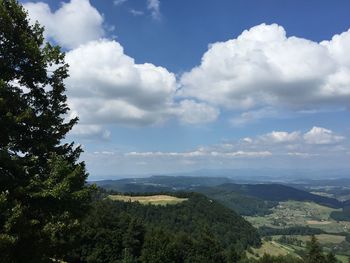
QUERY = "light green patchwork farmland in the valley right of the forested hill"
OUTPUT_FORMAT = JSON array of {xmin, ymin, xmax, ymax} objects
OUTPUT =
[{"xmin": 245, "ymin": 201, "xmax": 350, "ymax": 262}]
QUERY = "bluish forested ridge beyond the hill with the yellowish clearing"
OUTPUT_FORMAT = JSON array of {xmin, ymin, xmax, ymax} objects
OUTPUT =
[{"xmin": 95, "ymin": 176, "xmax": 343, "ymax": 215}]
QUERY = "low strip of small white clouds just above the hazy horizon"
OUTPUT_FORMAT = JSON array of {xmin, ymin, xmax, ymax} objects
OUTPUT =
[{"xmin": 126, "ymin": 127, "xmax": 347, "ymax": 158}]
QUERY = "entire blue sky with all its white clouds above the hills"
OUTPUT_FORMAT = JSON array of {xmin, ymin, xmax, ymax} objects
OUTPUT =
[{"xmin": 23, "ymin": 0, "xmax": 350, "ymax": 179}]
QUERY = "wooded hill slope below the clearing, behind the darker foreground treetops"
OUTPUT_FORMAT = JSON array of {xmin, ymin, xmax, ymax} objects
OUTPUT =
[{"xmin": 122, "ymin": 193, "xmax": 260, "ymax": 249}]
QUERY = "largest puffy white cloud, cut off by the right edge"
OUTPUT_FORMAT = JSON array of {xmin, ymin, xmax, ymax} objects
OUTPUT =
[{"xmin": 179, "ymin": 24, "xmax": 350, "ymax": 112}]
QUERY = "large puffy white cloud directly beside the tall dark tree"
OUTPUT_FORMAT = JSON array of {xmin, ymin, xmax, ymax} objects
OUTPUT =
[{"xmin": 66, "ymin": 40, "xmax": 176, "ymax": 128}]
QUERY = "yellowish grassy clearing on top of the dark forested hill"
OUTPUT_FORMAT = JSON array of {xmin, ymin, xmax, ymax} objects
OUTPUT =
[{"xmin": 108, "ymin": 195, "xmax": 188, "ymax": 205}]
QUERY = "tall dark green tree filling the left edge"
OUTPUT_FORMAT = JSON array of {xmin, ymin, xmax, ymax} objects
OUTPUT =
[{"xmin": 0, "ymin": 0, "xmax": 90, "ymax": 262}]
